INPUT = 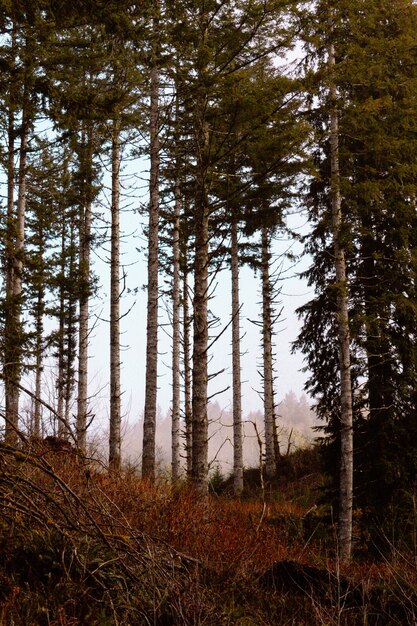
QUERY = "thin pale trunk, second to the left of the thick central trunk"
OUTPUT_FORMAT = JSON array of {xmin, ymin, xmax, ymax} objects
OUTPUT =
[{"xmin": 171, "ymin": 178, "xmax": 181, "ymax": 482}]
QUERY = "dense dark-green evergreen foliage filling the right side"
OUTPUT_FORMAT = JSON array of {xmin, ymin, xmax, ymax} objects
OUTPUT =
[{"xmin": 296, "ymin": 0, "xmax": 417, "ymax": 551}]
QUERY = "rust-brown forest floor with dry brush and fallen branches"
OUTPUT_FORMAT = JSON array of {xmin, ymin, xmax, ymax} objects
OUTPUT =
[{"xmin": 0, "ymin": 444, "xmax": 417, "ymax": 626}]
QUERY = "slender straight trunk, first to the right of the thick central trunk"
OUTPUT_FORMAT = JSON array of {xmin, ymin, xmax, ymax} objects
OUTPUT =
[{"xmin": 231, "ymin": 218, "xmax": 243, "ymax": 496}]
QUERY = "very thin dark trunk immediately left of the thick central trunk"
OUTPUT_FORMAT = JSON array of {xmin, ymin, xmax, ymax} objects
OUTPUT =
[{"xmin": 182, "ymin": 258, "xmax": 193, "ymax": 480}]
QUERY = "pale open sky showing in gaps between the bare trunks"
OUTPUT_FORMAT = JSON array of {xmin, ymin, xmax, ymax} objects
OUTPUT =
[{"xmin": 86, "ymin": 150, "xmax": 311, "ymax": 423}]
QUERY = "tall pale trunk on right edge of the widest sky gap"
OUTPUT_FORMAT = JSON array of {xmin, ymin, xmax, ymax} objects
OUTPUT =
[{"xmin": 142, "ymin": 20, "xmax": 160, "ymax": 483}]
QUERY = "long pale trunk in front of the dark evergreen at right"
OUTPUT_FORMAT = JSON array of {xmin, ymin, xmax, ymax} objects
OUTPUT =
[{"xmin": 329, "ymin": 43, "xmax": 353, "ymax": 561}]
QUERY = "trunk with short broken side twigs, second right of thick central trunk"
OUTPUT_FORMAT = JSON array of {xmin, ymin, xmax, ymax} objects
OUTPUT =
[{"xmin": 261, "ymin": 224, "xmax": 276, "ymax": 479}]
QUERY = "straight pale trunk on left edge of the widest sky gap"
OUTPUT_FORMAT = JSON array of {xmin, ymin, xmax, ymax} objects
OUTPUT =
[{"xmin": 109, "ymin": 120, "xmax": 121, "ymax": 471}]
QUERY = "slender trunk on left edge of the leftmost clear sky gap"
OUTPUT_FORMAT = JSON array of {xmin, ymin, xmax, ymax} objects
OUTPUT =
[{"xmin": 77, "ymin": 123, "xmax": 93, "ymax": 453}]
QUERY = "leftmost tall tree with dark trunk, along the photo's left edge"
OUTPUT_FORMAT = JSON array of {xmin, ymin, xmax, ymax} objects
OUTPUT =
[{"xmin": 3, "ymin": 11, "xmax": 38, "ymax": 443}]
